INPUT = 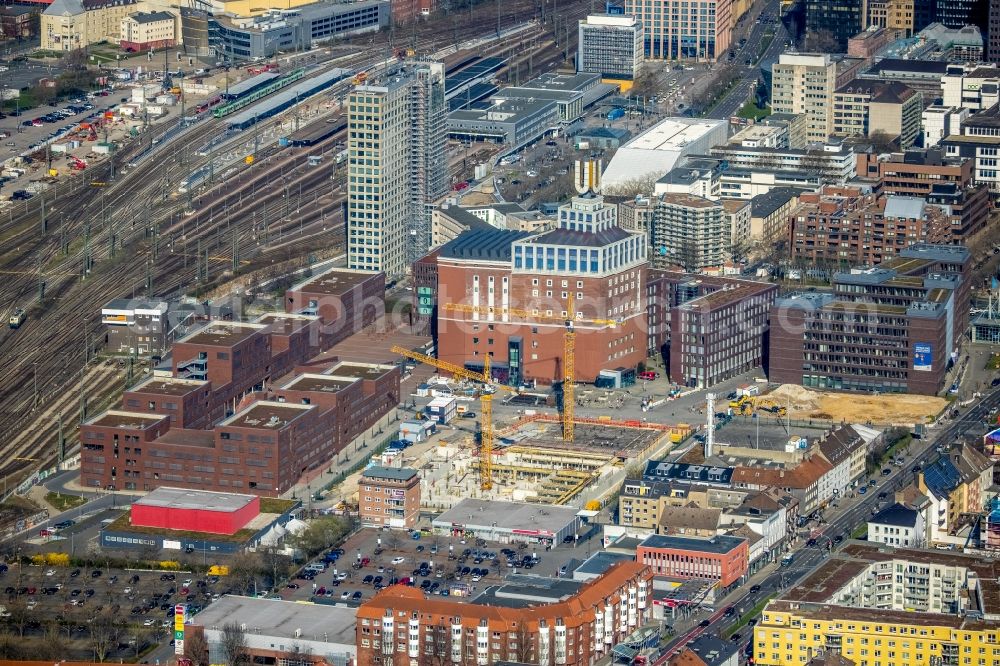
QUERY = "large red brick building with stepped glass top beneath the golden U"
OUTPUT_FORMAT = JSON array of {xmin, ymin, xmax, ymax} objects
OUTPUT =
[{"xmin": 437, "ymin": 196, "xmax": 647, "ymax": 384}]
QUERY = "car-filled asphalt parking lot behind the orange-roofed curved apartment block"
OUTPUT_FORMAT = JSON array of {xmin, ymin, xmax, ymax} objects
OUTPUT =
[{"xmin": 278, "ymin": 529, "xmax": 600, "ymax": 605}]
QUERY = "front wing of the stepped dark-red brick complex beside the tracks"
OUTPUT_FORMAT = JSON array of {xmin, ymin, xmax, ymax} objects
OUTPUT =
[{"xmin": 80, "ymin": 362, "xmax": 399, "ymax": 496}]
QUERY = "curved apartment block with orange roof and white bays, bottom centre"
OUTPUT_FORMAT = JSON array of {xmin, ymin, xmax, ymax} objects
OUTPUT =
[{"xmin": 357, "ymin": 562, "xmax": 653, "ymax": 666}]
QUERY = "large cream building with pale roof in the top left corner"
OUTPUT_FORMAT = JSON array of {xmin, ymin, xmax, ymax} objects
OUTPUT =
[{"xmin": 41, "ymin": 0, "xmax": 141, "ymax": 51}]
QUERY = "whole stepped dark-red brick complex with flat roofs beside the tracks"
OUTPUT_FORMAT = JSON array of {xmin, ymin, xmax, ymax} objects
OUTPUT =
[{"xmin": 80, "ymin": 269, "xmax": 400, "ymax": 496}]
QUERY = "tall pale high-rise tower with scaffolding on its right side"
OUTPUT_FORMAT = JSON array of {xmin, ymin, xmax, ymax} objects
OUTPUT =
[{"xmin": 347, "ymin": 62, "xmax": 448, "ymax": 277}]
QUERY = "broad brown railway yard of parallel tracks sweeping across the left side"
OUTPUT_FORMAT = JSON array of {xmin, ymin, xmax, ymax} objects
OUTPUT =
[{"xmin": 0, "ymin": 2, "xmax": 589, "ymax": 486}]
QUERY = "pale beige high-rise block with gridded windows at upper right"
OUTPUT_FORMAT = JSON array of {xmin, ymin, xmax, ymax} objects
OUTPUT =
[{"xmin": 771, "ymin": 53, "xmax": 836, "ymax": 142}]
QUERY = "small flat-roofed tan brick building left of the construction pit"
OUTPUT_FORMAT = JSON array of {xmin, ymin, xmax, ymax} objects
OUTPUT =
[{"xmin": 358, "ymin": 466, "xmax": 420, "ymax": 529}]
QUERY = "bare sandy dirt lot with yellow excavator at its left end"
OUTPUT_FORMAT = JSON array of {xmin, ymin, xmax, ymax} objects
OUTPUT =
[{"xmin": 768, "ymin": 384, "xmax": 948, "ymax": 425}]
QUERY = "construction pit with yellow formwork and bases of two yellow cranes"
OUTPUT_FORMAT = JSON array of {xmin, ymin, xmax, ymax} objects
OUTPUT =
[{"xmin": 393, "ymin": 347, "xmax": 691, "ymax": 509}]
